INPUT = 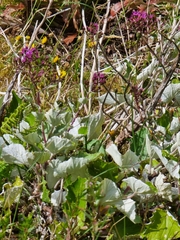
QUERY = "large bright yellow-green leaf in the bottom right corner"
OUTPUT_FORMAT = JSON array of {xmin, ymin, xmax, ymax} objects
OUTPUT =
[{"xmin": 141, "ymin": 209, "xmax": 180, "ymax": 240}]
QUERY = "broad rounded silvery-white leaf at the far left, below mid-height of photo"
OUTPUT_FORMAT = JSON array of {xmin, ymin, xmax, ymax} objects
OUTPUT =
[{"xmin": 2, "ymin": 144, "xmax": 29, "ymax": 165}]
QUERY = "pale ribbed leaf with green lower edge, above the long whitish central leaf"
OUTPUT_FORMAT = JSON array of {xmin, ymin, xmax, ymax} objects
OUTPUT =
[{"xmin": 46, "ymin": 136, "xmax": 77, "ymax": 154}]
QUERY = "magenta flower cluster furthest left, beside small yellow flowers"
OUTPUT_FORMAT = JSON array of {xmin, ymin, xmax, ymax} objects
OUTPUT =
[{"xmin": 21, "ymin": 47, "xmax": 39, "ymax": 63}]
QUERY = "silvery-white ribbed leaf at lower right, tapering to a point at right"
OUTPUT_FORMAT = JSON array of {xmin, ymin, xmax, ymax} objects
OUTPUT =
[{"xmin": 123, "ymin": 177, "xmax": 152, "ymax": 194}]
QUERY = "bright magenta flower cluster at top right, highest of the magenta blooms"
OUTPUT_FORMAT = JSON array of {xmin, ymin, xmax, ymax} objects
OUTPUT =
[{"xmin": 129, "ymin": 10, "xmax": 155, "ymax": 32}]
